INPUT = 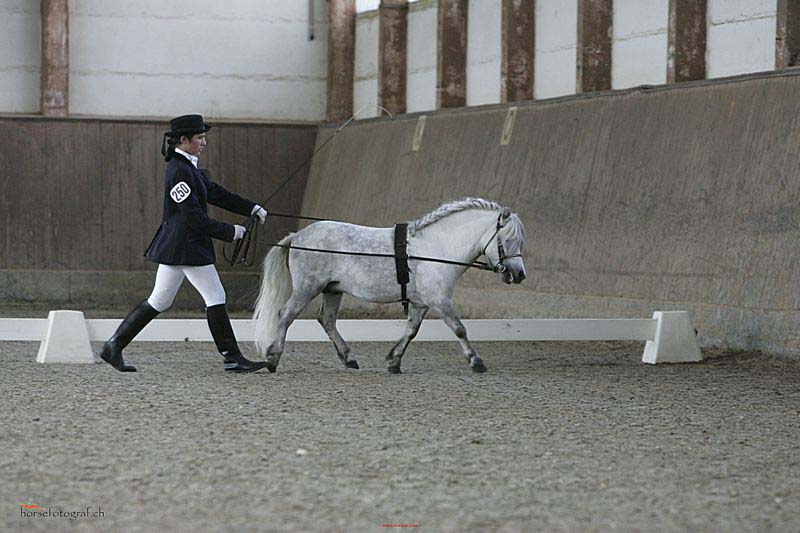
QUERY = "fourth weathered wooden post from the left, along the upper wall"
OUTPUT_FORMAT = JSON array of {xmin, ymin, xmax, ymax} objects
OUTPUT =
[{"xmin": 436, "ymin": 0, "xmax": 469, "ymax": 108}]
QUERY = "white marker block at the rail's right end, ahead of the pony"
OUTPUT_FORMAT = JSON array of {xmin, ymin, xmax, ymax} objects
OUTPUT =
[{"xmin": 642, "ymin": 311, "xmax": 703, "ymax": 365}]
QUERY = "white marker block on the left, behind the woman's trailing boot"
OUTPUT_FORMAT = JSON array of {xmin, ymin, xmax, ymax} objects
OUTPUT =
[{"xmin": 36, "ymin": 311, "xmax": 96, "ymax": 363}]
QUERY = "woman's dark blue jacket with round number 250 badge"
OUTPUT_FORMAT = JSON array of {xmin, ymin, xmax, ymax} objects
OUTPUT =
[{"xmin": 144, "ymin": 153, "xmax": 256, "ymax": 266}]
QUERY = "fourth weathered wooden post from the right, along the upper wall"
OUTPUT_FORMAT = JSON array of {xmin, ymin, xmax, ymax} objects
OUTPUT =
[{"xmin": 500, "ymin": 0, "xmax": 536, "ymax": 102}]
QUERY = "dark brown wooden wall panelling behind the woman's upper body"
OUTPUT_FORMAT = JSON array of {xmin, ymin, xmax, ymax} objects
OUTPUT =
[{"xmin": 0, "ymin": 116, "xmax": 317, "ymax": 271}]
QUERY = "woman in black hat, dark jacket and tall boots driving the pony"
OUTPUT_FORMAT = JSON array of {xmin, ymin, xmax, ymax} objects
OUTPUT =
[{"xmin": 100, "ymin": 115, "xmax": 267, "ymax": 372}]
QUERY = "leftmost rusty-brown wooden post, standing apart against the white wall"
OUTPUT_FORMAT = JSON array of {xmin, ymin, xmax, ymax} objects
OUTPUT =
[{"xmin": 41, "ymin": 0, "xmax": 69, "ymax": 117}]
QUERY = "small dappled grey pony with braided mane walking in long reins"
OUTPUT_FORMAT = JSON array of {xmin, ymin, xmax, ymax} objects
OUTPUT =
[{"xmin": 253, "ymin": 198, "xmax": 525, "ymax": 374}]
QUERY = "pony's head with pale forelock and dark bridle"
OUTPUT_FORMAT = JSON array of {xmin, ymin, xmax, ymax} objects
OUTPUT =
[{"xmin": 483, "ymin": 208, "xmax": 525, "ymax": 284}]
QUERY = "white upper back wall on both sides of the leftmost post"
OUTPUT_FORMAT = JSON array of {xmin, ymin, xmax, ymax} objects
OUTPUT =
[{"xmin": 0, "ymin": 0, "xmax": 328, "ymax": 120}]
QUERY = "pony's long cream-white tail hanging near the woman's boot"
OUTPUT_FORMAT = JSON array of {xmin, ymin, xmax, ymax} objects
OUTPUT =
[{"xmin": 253, "ymin": 233, "xmax": 294, "ymax": 356}]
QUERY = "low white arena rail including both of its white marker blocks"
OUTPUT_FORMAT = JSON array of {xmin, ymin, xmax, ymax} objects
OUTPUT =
[{"xmin": 0, "ymin": 311, "xmax": 702, "ymax": 364}]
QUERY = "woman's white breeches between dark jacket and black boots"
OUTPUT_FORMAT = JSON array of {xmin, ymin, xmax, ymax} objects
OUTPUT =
[{"xmin": 147, "ymin": 265, "xmax": 225, "ymax": 313}]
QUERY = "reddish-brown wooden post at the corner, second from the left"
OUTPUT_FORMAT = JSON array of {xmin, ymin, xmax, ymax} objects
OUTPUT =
[{"xmin": 326, "ymin": 0, "xmax": 356, "ymax": 122}]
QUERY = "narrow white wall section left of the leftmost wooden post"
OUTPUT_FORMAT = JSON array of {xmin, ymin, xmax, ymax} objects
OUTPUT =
[{"xmin": 0, "ymin": 0, "xmax": 42, "ymax": 113}]
